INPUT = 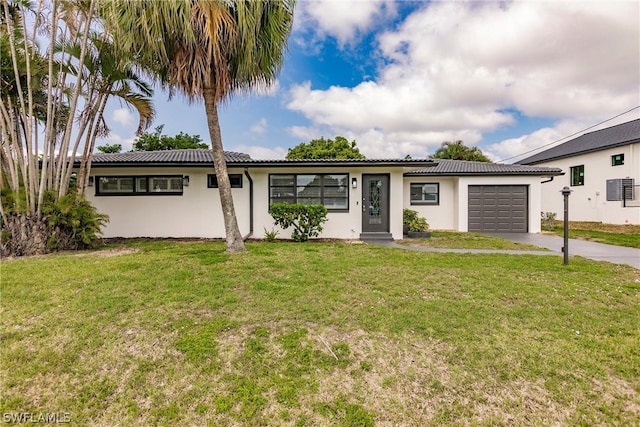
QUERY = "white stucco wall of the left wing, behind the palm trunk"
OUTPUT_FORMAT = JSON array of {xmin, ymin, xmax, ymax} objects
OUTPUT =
[{"xmin": 87, "ymin": 167, "xmax": 249, "ymax": 238}]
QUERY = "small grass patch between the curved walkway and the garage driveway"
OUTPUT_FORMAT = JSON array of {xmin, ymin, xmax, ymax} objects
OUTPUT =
[{"xmin": 397, "ymin": 231, "xmax": 546, "ymax": 251}]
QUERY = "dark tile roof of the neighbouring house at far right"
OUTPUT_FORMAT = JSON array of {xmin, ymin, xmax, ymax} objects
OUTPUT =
[{"xmin": 516, "ymin": 119, "xmax": 640, "ymax": 165}]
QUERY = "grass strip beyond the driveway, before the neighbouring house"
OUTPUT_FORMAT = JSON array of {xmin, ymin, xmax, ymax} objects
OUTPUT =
[{"xmin": 553, "ymin": 221, "xmax": 640, "ymax": 249}]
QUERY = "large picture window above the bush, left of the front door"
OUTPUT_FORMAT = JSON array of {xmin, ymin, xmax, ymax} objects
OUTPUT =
[{"xmin": 269, "ymin": 174, "xmax": 349, "ymax": 211}]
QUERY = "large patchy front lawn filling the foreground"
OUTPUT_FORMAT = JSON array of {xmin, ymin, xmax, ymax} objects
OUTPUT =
[{"xmin": 0, "ymin": 241, "xmax": 640, "ymax": 426}]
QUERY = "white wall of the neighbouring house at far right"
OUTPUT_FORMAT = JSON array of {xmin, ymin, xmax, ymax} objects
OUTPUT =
[{"xmin": 537, "ymin": 143, "xmax": 640, "ymax": 224}]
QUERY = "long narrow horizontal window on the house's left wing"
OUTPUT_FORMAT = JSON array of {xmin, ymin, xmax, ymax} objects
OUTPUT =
[{"xmin": 96, "ymin": 175, "xmax": 182, "ymax": 196}]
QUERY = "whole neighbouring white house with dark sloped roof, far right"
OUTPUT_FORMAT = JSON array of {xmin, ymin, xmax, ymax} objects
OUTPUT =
[{"xmin": 517, "ymin": 119, "xmax": 640, "ymax": 224}]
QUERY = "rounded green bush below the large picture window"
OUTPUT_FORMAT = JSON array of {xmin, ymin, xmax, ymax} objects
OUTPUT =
[{"xmin": 270, "ymin": 203, "xmax": 328, "ymax": 242}]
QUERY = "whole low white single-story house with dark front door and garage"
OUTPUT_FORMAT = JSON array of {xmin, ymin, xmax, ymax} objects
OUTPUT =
[{"xmin": 82, "ymin": 149, "xmax": 561, "ymax": 239}]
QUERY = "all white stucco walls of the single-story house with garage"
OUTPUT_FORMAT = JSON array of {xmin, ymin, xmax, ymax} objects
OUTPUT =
[{"xmin": 87, "ymin": 167, "xmax": 561, "ymax": 239}]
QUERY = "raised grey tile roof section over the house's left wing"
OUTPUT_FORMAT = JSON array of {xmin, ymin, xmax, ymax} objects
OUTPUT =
[{"xmin": 92, "ymin": 148, "xmax": 251, "ymax": 166}]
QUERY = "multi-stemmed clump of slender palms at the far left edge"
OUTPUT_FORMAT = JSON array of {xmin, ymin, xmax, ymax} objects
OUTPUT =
[{"xmin": 0, "ymin": 0, "xmax": 153, "ymax": 254}]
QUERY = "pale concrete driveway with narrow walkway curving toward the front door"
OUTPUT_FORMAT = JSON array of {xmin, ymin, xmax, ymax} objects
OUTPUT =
[{"xmin": 367, "ymin": 233, "xmax": 640, "ymax": 269}]
